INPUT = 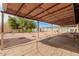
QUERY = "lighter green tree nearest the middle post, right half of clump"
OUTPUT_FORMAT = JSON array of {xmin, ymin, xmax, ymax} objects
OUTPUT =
[{"xmin": 18, "ymin": 17, "xmax": 36, "ymax": 32}]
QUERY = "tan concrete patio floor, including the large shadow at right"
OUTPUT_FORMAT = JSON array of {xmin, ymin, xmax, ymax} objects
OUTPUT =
[{"xmin": 0, "ymin": 33, "xmax": 79, "ymax": 56}]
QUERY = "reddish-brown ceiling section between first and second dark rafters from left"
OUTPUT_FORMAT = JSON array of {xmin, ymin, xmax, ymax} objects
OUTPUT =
[{"xmin": 17, "ymin": 3, "xmax": 39, "ymax": 17}]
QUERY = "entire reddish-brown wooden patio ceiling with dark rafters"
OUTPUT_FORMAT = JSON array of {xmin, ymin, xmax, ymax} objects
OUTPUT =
[{"xmin": 3, "ymin": 3, "xmax": 76, "ymax": 25}]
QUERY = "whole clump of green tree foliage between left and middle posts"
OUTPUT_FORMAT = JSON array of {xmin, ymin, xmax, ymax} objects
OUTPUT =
[{"xmin": 8, "ymin": 16, "xmax": 36, "ymax": 32}]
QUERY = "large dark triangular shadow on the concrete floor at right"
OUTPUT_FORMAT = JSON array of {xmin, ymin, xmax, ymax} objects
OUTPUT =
[{"xmin": 39, "ymin": 33, "xmax": 79, "ymax": 53}]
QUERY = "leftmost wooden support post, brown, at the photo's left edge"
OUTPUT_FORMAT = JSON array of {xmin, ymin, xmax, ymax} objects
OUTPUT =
[{"xmin": 1, "ymin": 12, "xmax": 4, "ymax": 50}]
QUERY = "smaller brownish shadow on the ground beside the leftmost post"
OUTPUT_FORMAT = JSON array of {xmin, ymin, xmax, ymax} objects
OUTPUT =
[{"xmin": 0, "ymin": 37, "xmax": 32, "ymax": 48}]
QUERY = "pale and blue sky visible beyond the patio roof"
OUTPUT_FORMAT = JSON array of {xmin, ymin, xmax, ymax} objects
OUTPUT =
[{"xmin": 0, "ymin": 3, "xmax": 56, "ymax": 27}]
